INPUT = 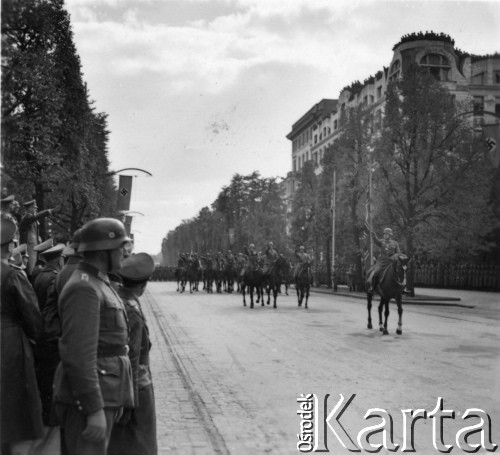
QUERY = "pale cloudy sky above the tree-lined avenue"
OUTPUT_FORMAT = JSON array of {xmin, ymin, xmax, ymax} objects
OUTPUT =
[{"xmin": 65, "ymin": 0, "xmax": 500, "ymax": 254}]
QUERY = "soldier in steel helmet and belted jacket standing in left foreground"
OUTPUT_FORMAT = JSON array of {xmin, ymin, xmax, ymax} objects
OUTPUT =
[{"xmin": 54, "ymin": 218, "xmax": 134, "ymax": 455}]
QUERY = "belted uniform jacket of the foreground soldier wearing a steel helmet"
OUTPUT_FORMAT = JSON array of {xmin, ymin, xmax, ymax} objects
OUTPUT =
[{"xmin": 54, "ymin": 261, "xmax": 134, "ymax": 415}]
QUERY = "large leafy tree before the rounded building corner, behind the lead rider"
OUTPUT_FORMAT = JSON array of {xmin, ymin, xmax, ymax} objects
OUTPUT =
[{"xmin": 374, "ymin": 66, "xmax": 493, "ymax": 292}]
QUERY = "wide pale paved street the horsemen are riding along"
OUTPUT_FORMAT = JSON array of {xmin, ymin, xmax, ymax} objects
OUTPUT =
[{"xmin": 144, "ymin": 282, "xmax": 500, "ymax": 454}]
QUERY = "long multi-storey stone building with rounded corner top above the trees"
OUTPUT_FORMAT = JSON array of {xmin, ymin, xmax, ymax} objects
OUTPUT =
[{"xmin": 284, "ymin": 32, "xmax": 500, "ymax": 216}]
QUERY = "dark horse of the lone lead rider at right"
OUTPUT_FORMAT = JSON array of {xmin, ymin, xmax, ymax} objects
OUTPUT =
[{"xmin": 366, "ymin": 253, "xmax": 409, "ymax": 335}]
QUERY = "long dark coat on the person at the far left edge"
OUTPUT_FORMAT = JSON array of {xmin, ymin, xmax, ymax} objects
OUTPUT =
[{"xmin": 0, "ymin": 264, "xmax": 43, "ymax": 443}]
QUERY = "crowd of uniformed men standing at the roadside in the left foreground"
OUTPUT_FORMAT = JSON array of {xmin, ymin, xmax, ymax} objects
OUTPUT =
[{"xmin": 0, "ymin": 216, "xmax": 157, "ymax": 455}]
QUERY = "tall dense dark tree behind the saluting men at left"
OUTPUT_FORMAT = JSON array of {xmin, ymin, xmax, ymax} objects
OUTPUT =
[{"xmin": 2, "ymin": 0, "xmax": 116, "ymax": 239}]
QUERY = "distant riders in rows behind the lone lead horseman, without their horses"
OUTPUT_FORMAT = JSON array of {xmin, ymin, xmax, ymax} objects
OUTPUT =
[{"xmin": 177, "ymin": 242, "xmax": 311, "ymax": 278}]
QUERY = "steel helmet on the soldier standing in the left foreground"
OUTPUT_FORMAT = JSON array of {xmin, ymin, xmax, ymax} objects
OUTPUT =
[{"xmin": 78, "ymin": 218, "xmax": 131, "ymax": 253}]
